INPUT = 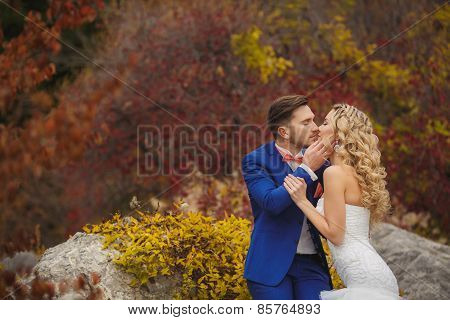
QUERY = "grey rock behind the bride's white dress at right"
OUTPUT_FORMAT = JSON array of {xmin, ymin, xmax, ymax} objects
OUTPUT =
[{"xmin": 371, "ymin": 223, "xmax": 450, "ymax": 300}]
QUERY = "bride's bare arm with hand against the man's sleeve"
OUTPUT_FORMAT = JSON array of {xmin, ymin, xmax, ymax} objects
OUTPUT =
[{"xmin": 285, "ymin": 166, "xmax": 345, "ymax": 245}]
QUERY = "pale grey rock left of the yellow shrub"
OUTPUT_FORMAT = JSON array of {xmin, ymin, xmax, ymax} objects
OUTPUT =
[{"xmin": 34, "ymin": 232, "xmax": 179, "ymax": 300}]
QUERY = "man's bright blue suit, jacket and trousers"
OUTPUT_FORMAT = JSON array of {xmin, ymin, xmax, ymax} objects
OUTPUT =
[{"xmin": 242, "ymin": 141, "xmax": 333, "ymax": 299}]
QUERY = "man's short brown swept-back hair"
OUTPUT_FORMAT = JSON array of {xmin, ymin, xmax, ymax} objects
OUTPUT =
[{"xmin": 267, "ymin": 95, "xmax": 308, "ymax": 139}]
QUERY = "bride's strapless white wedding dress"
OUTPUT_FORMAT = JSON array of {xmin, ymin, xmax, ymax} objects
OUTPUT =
[{"xmin": 316, "ymin": 197, "xmax": 402, "ymax": 300}]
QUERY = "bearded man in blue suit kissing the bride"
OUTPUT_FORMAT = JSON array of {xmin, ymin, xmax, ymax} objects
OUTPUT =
[{"xmin": 242, "ymin": 95, "xmax": 333, "ymax": 300}]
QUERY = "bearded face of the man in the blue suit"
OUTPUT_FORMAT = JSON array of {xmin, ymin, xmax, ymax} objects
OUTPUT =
[{"xmin": 283, "ymin": 105, "xmax": 319, "ymax": 147}]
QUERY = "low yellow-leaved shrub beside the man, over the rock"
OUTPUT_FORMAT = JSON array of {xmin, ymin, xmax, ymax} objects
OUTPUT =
[{"xmin": 83, "ymin": 204, "xmax": 251, "ymax": 299}]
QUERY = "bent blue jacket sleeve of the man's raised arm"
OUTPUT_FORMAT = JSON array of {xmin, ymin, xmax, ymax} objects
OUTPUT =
[{"xmin": 242, "ymin": 154, "xmax": 313, "ymax": 216}]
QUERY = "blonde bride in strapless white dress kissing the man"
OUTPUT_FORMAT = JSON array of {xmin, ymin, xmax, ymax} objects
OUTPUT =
[{"xmin": 284, "ymin": 104, "xmax": 401, "ymax": 300}]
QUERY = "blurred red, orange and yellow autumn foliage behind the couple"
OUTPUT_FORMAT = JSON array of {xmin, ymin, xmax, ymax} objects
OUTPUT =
[{"xmin": 0, "ymin": 0, "xmax": 450, "ymax": 256}]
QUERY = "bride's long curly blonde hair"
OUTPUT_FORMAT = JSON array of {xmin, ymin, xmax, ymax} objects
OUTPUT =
[{"xmin": 331, "ymin": 103, "xmax": 392, "ymax": 230}]
